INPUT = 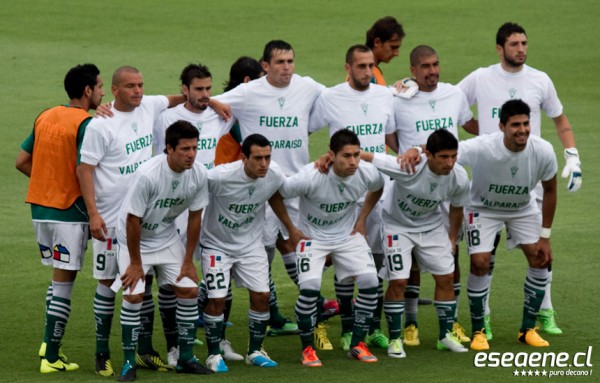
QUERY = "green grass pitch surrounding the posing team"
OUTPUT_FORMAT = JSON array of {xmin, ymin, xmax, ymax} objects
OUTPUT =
[{"xmin": 0, "ymin": 0, "xmax": 600, "ymax": 382}]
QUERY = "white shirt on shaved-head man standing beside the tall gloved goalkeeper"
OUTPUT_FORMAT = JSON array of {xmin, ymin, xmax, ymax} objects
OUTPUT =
[{"xmin": 394, "ymin": 82, "xmax": 473, "ymax": 153}]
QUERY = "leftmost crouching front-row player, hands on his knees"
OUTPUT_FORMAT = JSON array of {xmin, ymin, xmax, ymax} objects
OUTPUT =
[{"xmin": 113, "ymin": 121, "xmax": 212, "ymax": 382}]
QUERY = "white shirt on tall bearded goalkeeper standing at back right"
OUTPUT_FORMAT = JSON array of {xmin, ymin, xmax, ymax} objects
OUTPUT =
[{"xmin": 458, "ymin": 64, "xmax": 563, "ymax": 136}]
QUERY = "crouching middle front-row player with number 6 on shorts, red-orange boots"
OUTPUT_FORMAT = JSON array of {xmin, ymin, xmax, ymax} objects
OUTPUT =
[{"xmin": 274, "ymin": 129, "xmax": 383, "ymax": 367}]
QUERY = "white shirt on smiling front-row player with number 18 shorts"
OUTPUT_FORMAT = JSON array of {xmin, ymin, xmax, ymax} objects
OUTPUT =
[{"xmin": 458, "ymin": 132, "xmax": 558, "ymax": 219}]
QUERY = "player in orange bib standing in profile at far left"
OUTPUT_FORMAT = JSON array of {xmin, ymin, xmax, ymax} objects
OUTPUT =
[{"xmin": 16, "ymin": 64, "xmax": 104, "ymax": 374}]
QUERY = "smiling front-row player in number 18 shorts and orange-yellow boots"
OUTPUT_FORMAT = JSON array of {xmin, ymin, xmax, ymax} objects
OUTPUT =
[{"xmin": 458, "ymin": 100, "xmax": 558, "ymax": 351}]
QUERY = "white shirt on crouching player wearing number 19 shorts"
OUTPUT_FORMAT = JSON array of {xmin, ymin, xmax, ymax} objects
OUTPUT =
[{"xmin": 373, "ymin": 154, "xmax": 469, "ymax": 233}]
